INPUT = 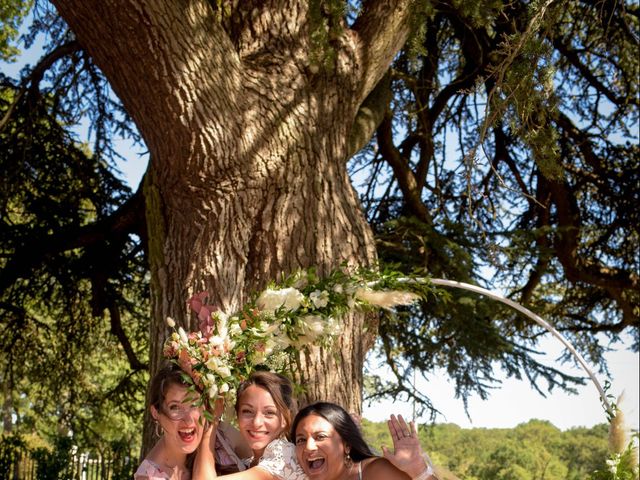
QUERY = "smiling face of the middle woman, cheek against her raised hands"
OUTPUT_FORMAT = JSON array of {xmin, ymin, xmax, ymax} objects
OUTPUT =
[{"xmin": 238, "ymin": 385, "xmax": 284, "ymax": 458}]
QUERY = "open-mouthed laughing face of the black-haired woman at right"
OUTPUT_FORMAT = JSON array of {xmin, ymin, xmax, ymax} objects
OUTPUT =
[{"xmin": 295, "ymin": 415, "xmax": 349, "ymax": 480}]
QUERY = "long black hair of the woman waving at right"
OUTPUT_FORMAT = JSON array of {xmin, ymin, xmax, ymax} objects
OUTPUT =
[{"xmin": 291, "ymin": 402, "xmax": 376, "ymax": 462}]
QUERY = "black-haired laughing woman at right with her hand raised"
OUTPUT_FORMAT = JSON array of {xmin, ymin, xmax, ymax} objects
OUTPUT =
[{"xmin": 291, "ymin": 402, "xmax": 437, "ymax": 480}]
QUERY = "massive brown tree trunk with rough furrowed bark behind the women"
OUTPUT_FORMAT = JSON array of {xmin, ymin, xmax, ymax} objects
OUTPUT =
[{"xmin": 48, "ymin": 0, "xmax": 409, "ymax": 454}]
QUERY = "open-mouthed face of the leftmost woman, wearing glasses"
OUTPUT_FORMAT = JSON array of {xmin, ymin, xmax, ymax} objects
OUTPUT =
[{"xmin": 152, "ymin": 384, "xmax": 203, "ymax": 454}]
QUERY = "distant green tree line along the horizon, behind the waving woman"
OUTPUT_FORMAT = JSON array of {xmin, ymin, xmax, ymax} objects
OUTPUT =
[{"xmin": 362, "ymin": 420, "xmax": 608, "ymax": 480}]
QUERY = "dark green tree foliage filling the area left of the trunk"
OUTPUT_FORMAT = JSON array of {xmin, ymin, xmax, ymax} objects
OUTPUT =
[{"xmin": 0, "ymin": 2, "xmax": 148, "ymax": 448}]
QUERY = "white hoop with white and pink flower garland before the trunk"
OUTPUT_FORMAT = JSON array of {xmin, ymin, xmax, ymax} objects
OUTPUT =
[{"xmin": 163, "ymin": 269, "xmax": 614, "ymax": 415}]
